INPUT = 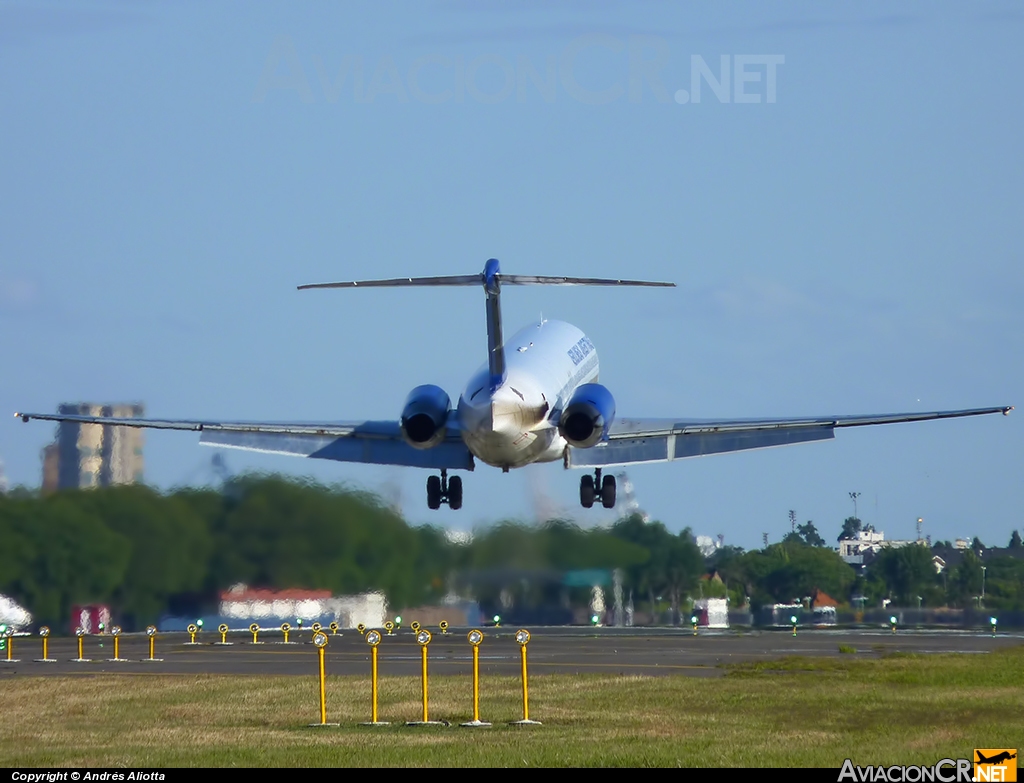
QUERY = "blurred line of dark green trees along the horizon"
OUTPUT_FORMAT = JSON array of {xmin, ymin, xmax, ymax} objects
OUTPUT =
[{"xmin": 0, "ymin": 476, "xmax": 1024, "ymax": 627}]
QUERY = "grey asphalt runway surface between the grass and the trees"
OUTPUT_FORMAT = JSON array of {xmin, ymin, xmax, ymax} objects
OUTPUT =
[{"xmin": 0, "ymin": 627, "xmax": 1024, "ymax": 678}]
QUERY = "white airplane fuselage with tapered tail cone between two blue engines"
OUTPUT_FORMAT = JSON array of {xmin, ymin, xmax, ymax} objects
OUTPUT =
[{"xmin": 455, "ymin": 320, "xmax": 598, "ymax": 470}]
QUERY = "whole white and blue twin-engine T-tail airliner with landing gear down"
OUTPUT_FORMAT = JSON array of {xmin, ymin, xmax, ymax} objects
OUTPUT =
[{"xmin": 15, "ymin": 259, "xmax": 1013, "ymax": 509}]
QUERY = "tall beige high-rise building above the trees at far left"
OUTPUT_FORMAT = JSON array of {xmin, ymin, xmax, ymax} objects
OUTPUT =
[{"xmin": 43, "ymin": 402, "xmax": 143, "ymax": 491}]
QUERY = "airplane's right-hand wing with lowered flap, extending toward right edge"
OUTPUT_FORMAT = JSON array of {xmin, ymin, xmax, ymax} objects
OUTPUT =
[{"xmin": 565, "ymin": 405, "xmax": 1013, "ymax": 468}]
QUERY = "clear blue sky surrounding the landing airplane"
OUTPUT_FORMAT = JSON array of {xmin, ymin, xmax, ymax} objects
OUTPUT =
[{"xmin": 0, "ymin": 2, "xmax": 1024, "ymax": 548}]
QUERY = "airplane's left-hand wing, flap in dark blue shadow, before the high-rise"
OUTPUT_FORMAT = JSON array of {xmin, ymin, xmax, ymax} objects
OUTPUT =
[{"xmin": 15, "ymin": 414, "xmax": 474, "ymax": 471}]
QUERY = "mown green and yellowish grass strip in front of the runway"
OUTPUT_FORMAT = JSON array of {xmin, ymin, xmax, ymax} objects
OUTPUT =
[{"xmin": 0, "ymin": 648, "xmax": 1024, "ymax": 769}]
